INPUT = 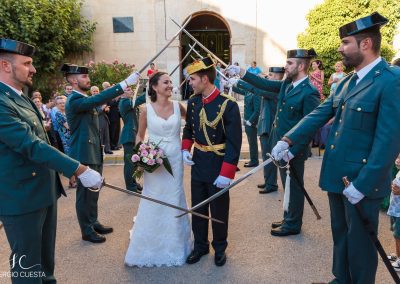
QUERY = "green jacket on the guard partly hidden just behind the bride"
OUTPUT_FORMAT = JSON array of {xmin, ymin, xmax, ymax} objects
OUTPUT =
[{"xmin": 118, "ymin": 94, "xmax": 146, "ymax": 144}]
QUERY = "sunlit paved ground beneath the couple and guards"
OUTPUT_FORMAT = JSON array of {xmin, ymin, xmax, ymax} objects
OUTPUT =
[{"xmin": 0, "ymin": 158, "xmax": 394, "ymax": 283}]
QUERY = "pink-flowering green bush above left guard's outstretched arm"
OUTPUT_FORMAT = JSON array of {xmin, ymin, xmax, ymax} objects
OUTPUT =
[{"xmin": 88, "ymin": 60, "xmax": 135, "ymax": 89}]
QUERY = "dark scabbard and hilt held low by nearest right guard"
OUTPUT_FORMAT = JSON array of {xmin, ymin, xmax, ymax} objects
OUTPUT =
[{"xmin": 342, "ymin": 177, "xmax": 400, "ymax": 283}]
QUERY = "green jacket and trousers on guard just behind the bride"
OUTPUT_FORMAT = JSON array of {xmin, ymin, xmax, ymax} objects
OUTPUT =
[{"xmin": 118, "ymin": 94, "xmax": 146, "ymax": 191}]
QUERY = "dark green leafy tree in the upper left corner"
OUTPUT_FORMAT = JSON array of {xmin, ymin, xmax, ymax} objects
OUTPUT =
[{"xmin": 0, "ymin": 0, "xmax": 96, "ymax": 100}]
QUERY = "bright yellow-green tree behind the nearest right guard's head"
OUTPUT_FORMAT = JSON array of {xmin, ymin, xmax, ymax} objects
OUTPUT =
[{"xmin": 297, "ymin": 0, "xmax": 400, "ymax": 94}]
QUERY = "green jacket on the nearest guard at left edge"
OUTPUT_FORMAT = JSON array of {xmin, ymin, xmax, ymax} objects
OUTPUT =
[{"xmin": 0, "ymin": 82, "xmax": 79, "ymax": 215}]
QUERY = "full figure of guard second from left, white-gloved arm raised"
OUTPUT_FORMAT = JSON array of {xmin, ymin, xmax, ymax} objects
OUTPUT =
[{"xmin": 61, "ymin": 64, "xmax": 139, "ymax": 243}]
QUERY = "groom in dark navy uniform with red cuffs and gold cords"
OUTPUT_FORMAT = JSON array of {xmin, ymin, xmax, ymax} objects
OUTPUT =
[{"xmin": 182, "ymin": 57, "xmax": 242, "ymax": 266}]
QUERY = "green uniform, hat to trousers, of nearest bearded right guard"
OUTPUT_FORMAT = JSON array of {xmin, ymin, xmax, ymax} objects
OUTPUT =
[{"xmin": 285, "ymin": 13, "xmax": 400, "ymax": 284}]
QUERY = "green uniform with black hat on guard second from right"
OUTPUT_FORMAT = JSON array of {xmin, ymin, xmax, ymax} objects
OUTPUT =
[{"xmin": 243, "ymin": 49, "xmax": 320, "ymax": 235}]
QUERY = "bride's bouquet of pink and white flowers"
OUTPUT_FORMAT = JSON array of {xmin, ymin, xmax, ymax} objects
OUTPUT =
[{"xmin": 131, "ymin": 141, "xmax": 173, "ymax": 179}]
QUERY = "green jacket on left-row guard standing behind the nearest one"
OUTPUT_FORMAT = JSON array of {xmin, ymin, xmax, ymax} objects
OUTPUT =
[{"xmin": 65, "ymin": 84, "xmax": 124, "ymax": 165}]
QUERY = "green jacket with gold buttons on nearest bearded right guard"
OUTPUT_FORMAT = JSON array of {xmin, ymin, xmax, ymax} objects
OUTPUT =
[{"xmin": 286, "ymin": 60, "xmax": 400, "ymax": 198}]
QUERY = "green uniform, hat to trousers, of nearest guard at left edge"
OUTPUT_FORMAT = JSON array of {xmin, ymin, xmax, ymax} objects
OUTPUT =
[{"xmin": 0, "ymin": 39, "xmax": 79, "ymax": 283}]
